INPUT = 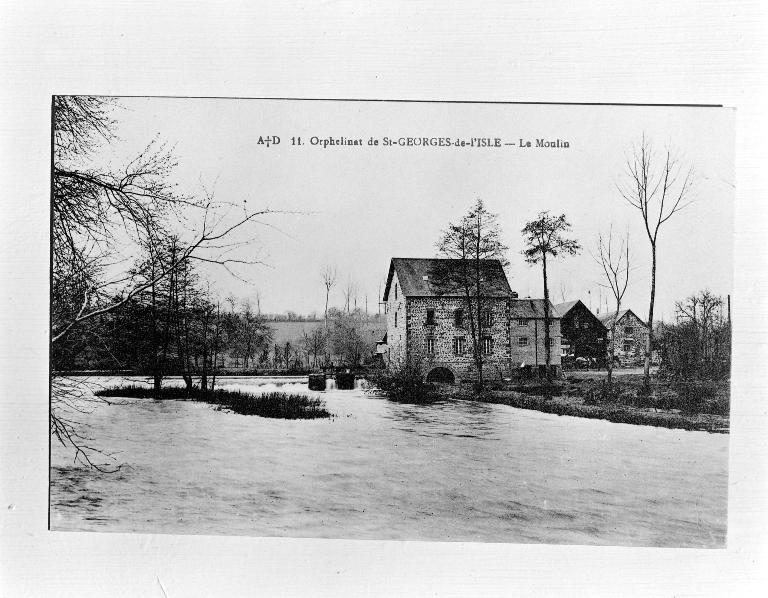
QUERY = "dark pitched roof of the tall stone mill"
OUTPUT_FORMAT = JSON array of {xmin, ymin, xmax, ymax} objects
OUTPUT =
[{"xmin": 383, "ymin": 257, "xmax": 512, "ymax": 301}]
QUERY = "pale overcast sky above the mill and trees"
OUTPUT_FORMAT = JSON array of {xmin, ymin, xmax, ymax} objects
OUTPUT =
[{"xmin": 99, "ymin": 98, "xmax": 734, "ymax": 318}]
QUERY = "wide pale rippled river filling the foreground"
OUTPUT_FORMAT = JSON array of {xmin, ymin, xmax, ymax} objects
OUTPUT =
[{"xmin": 50, "ymin": 378, "xmax": 728, "ymax": 547}]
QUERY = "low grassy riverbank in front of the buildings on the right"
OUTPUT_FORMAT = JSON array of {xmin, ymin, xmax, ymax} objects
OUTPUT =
[{"xmin": 441, "ymin": 376, "xmax": 729, "ymax": 433}]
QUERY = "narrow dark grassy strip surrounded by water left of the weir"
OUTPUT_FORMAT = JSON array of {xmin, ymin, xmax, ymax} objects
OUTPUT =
[{"xmin": 94, "ymin": 385, "xmax": 331, "ymax": 419}]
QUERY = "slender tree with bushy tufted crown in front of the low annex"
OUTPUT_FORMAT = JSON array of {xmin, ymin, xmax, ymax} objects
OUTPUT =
[{"xmin": 522, "ymin": 212, "xmax": 581, "ymax": 382}]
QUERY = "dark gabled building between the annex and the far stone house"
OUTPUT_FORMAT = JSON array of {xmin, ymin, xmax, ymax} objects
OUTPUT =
[{"xmin": 555, "ymin": 299, "xmax": 608, "ymax": 367}]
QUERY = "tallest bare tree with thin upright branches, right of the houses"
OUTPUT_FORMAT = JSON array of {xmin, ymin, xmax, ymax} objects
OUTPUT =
[{"xmin": 617, "ymin": 134, "xmax": 694, "ymax": 386}]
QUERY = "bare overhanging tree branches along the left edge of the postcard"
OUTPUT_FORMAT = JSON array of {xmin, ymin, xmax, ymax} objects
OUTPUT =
[{"xmin": 50, "ymin": 96, "xmax": 284, "ymax": 465}]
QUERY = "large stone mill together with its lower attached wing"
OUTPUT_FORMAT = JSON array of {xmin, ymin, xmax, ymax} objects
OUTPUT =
[{"xmin": 379, "ymin": 258, "xmax": 560, "ymax": 382}]
